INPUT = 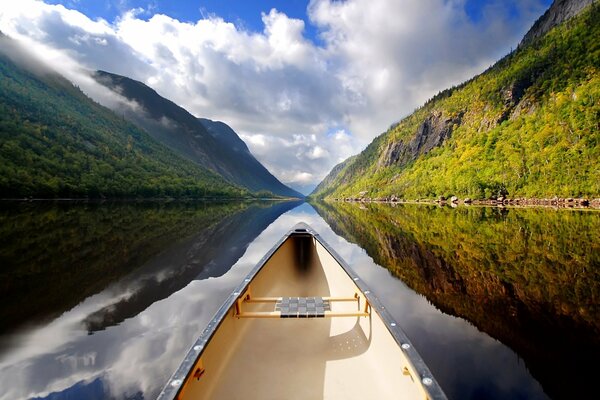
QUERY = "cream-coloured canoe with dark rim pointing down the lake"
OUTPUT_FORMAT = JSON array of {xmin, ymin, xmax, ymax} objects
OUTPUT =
[{"xmin": 159, "ymin": 224, "xmax": 446, "ymax": 400}]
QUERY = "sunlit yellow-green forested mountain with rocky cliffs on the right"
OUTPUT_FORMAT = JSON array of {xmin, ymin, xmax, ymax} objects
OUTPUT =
[{"xmin": 311, "ymin": 0, "xmax": 600, "ymax": 199}]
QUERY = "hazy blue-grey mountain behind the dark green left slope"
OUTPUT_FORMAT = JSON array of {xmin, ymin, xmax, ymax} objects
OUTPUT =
[{"xmin": 94, "ymin": 71, "xmax": 304, "ymax": 198}]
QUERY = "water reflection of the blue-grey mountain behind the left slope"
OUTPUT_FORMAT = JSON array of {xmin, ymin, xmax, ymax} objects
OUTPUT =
[{"xmin": 85, "ymin": 202, "xmax": 301, "ymax": 332}]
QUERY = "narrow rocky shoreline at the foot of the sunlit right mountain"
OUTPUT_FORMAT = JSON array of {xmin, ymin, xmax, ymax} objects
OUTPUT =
[{"xmin": 329, "ymin": 196, "xmax": 600, "ymax": 210}]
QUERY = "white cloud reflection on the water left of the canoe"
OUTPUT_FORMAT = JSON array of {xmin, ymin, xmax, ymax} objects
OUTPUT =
[{"xmin": 0, "ymin": 206, "xmax": 323, "ymax": 400}]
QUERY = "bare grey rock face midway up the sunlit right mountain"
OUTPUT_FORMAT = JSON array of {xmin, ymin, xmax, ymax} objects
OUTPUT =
[{"xmin": 378, "ymin": 112, "xmax": 462, "ymax": 167}]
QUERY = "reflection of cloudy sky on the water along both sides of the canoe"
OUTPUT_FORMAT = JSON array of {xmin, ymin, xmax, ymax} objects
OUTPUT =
[{"xmin": 0, "ymin": 204, "xmax": 539, "ymax": 400}]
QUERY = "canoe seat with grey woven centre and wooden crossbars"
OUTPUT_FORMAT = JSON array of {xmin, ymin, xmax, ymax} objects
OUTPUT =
[{"xmin": 235, "ymin": 291, "xmax": 371, "ymax": 318}]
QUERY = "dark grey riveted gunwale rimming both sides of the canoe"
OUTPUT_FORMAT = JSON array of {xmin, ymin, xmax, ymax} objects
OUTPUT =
[{"xmin": 158, "ymin": 223, "xmax": 447, "ymax": 400}]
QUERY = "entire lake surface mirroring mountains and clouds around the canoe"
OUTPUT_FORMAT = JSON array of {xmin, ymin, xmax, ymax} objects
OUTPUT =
[{"xmin": 0, "ymin": 203, "xmax": 598, "ymax": 400}]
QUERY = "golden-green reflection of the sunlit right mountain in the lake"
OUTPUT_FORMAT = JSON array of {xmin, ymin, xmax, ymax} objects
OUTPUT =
[{"xmin": 314, "ymin": 203, "xmax": 600, "ymax": 399}]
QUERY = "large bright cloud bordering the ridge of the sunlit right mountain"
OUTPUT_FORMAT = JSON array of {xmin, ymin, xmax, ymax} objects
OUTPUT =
[{"xmin": 308, "ymin": 0, "xmax": 543, "ymax": 138}]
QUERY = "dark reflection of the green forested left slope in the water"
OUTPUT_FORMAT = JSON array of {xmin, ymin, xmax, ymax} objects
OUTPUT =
[{"xmin": 0, "ymin": 202, "xmax": 252, "ymax": 332}]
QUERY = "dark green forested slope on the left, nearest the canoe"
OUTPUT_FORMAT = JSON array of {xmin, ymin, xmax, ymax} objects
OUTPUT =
[{"xmin": 0, "ymin": 35, "xmax": 248, "ymax": 198}]
